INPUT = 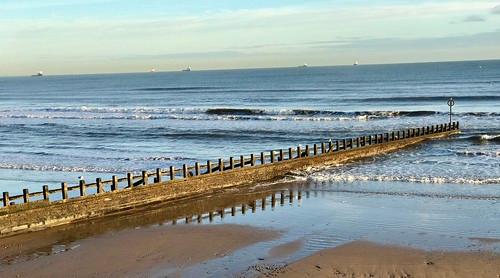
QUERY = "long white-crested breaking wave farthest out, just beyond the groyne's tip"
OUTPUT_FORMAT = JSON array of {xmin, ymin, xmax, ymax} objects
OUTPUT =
[{"xmin": 0, "ymin": 106, "xmax": 500, "ymax": 121}]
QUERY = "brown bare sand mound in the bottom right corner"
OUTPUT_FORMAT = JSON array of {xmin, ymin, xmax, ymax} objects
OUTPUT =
[{"xmin": 272, "ymin": 241, "xmax": 500, "ymax": 278}]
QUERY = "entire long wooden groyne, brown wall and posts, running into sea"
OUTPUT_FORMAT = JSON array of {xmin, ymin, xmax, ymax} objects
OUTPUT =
[{"xmin": 0, "ymin": 122, "xmax": 459, "ymax": 237}]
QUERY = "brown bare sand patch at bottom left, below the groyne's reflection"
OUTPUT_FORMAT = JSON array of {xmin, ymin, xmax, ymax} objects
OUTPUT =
[{"xmin": 0, "ymin": 225, "xmax": 280, "ymax": 277}]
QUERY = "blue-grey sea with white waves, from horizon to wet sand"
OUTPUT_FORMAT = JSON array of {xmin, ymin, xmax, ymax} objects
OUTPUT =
[{"xmin": 0, "ymin": 61, "xmax": 500, "ymax": 197}]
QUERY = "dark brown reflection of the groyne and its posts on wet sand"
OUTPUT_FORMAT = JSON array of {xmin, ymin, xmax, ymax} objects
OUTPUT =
[{"xmin": 0, "ymin": 182, "xmax": 310, "ymax": 264}]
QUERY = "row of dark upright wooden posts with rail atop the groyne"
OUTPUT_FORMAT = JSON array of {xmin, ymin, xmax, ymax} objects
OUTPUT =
[{"xmin": 0, "ymin": 122, "xmax": 459, "ymax": 207}]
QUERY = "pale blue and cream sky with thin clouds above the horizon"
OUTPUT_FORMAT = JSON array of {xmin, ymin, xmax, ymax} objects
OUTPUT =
[{"xmin": 0, "ymin": 0, "xmax": 500, "ymax": 76}]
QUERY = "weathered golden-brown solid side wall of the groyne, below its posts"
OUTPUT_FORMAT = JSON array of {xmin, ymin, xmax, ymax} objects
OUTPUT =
[{"xmin": 0, "ymin": 130, "xmax": 459, "ymax": 237}]
